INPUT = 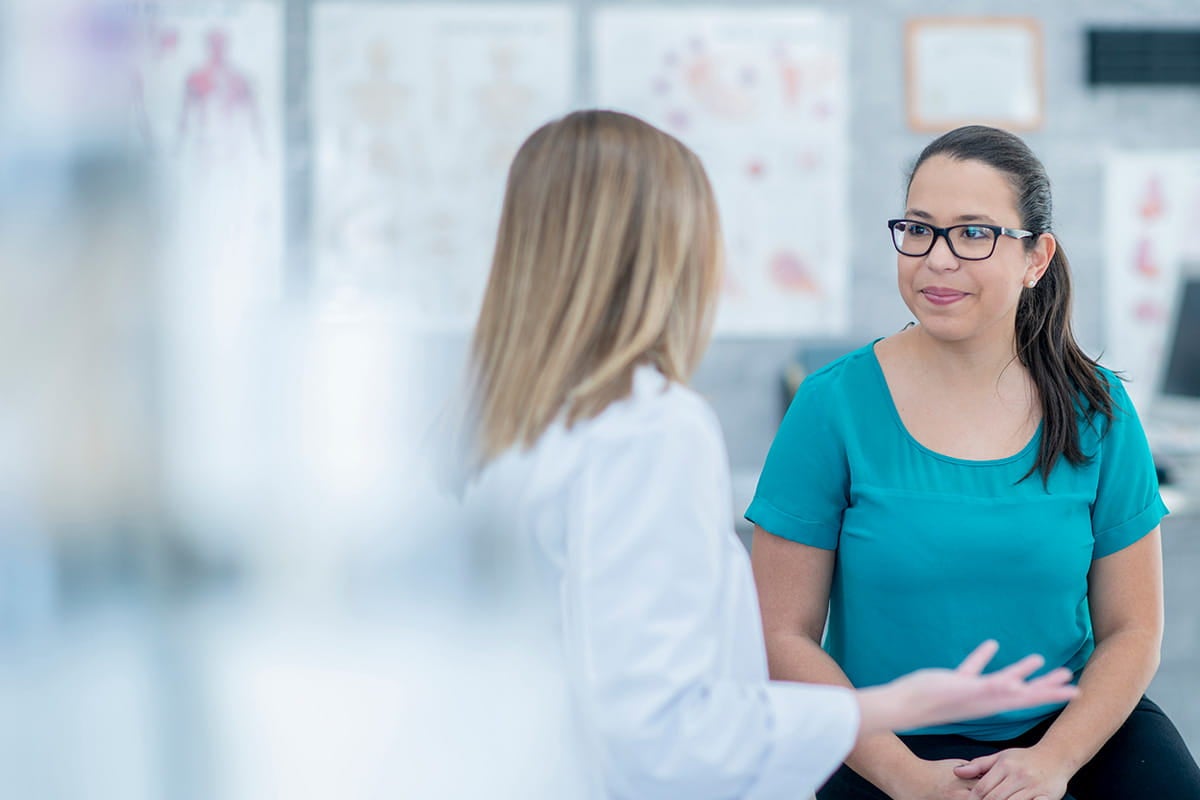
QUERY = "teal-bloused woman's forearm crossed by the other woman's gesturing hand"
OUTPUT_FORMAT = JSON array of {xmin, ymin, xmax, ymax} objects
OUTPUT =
[{"xmin": 767, "ymin": 633, "xmax": 917, "ymax": 794}]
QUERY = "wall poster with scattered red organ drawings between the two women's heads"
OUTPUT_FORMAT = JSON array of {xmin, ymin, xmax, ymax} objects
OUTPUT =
[{"xmin": 593, "ymin": 7, "xmax": 850, "ymax": 336}]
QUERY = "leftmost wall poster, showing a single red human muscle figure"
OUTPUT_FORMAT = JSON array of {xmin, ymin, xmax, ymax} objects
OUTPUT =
[{"xmin": 130, "ymin": 0, "xmax": 283, "ymax": 309}]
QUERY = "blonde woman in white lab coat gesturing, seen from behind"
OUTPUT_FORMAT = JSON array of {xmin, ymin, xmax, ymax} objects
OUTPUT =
[{"xmin": 460, "ymin": 110, "xmax": 1075, "ymax": 800}]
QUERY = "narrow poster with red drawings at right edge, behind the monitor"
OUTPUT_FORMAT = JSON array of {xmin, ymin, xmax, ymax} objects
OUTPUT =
[{"xmin": 1104, "ymin": 151, "xmax": 1200, "ymax": 408}]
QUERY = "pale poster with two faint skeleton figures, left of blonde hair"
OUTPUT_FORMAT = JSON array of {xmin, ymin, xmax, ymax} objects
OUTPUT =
[{"xmin": 312, "ymin": 4, "xmax": 575, "ymax": 330}]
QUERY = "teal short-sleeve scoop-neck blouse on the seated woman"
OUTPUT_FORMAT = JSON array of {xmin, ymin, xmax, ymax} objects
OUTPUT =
[{"xmin": 745, "ymin": 344, "xmax": 1168, "ymax": 740}]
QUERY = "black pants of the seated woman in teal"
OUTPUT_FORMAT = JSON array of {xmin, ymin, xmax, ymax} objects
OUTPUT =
[{"xmin": 817, "ymin": 697, "xmax": 1200, "ymax": 800}]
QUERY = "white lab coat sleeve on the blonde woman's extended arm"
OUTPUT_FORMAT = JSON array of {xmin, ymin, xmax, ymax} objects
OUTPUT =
[{"xmin": 563, "ymin": 402, "xmax": 859, "ymax": 800}]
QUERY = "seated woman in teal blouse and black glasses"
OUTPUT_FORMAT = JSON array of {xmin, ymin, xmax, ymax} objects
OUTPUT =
[{"xmin": 746, "ymin": 126, "xmax": 1200, "ymax": 800}]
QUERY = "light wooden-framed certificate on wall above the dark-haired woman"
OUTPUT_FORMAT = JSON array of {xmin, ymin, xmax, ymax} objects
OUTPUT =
[{"xmin": 905, "ymin": 17, "xmax": 1045, "ymax": 133}]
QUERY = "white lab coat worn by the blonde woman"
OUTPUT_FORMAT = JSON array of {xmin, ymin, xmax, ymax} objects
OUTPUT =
[{"xmin": 472, "ymin": 367, "xmax": 858, "ymax": 800}]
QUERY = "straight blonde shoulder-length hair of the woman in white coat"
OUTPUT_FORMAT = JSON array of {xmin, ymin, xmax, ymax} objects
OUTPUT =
[{"xmin": 470, "ymin": 110, "xmax": 722, "ymax": 465}]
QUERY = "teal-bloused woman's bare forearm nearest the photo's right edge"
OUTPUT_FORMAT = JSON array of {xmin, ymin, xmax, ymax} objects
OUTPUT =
[{"xmin": 1038, "ymin": 628, "xmax": 1159, "ymax": 774}]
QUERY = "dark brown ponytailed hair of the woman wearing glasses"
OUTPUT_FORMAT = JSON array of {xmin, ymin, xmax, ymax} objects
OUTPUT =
[{"xmin": 908, "ymin": 125, "xmax": 1114, "ymax": 483}]
